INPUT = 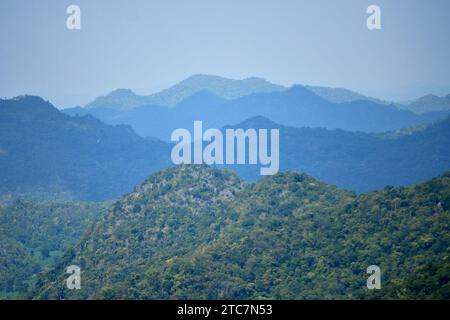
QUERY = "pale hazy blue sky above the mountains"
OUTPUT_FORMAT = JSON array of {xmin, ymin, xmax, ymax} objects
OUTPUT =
[{"xmin": 0, "ymin": 0, "xmax": 450, "ymax": 107}]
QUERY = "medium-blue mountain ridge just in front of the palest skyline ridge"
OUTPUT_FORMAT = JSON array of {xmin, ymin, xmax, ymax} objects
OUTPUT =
[{"xmin": 64, "ymin": 86, "xmax": 450, "ymax": 141}]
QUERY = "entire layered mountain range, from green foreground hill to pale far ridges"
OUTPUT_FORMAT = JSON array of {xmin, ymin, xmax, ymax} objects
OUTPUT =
[{"xmin": 0, "ymin": 75, "xmax": 450, "ymax": 299}]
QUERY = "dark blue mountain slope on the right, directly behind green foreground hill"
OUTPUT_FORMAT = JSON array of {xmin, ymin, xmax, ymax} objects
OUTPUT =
[{"xmin": 227, "ymin": 117, "xmax": 450, "ymax": 192}]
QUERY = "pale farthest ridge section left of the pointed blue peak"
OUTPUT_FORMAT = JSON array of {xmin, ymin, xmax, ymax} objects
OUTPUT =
[{"xmin": 86, "ymin": 74, "xmax": 284, "ymax": 110}]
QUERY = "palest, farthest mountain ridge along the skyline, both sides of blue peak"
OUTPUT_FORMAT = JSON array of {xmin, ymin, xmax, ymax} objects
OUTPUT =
[{"xmin": 68, "ymin": 74, "xmax": 450, "ymax": 119}]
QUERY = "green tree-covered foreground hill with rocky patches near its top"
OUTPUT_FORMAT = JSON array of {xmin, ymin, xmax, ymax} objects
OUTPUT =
[{"xmin": 29, "ymin": 166, "xmax": 450, "ymax": 299}]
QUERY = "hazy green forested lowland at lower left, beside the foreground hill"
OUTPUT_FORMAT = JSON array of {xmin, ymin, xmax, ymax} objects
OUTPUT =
[{"xmin": 0, "ymin": 200, "xmax": 108, "ymax": 298}]
